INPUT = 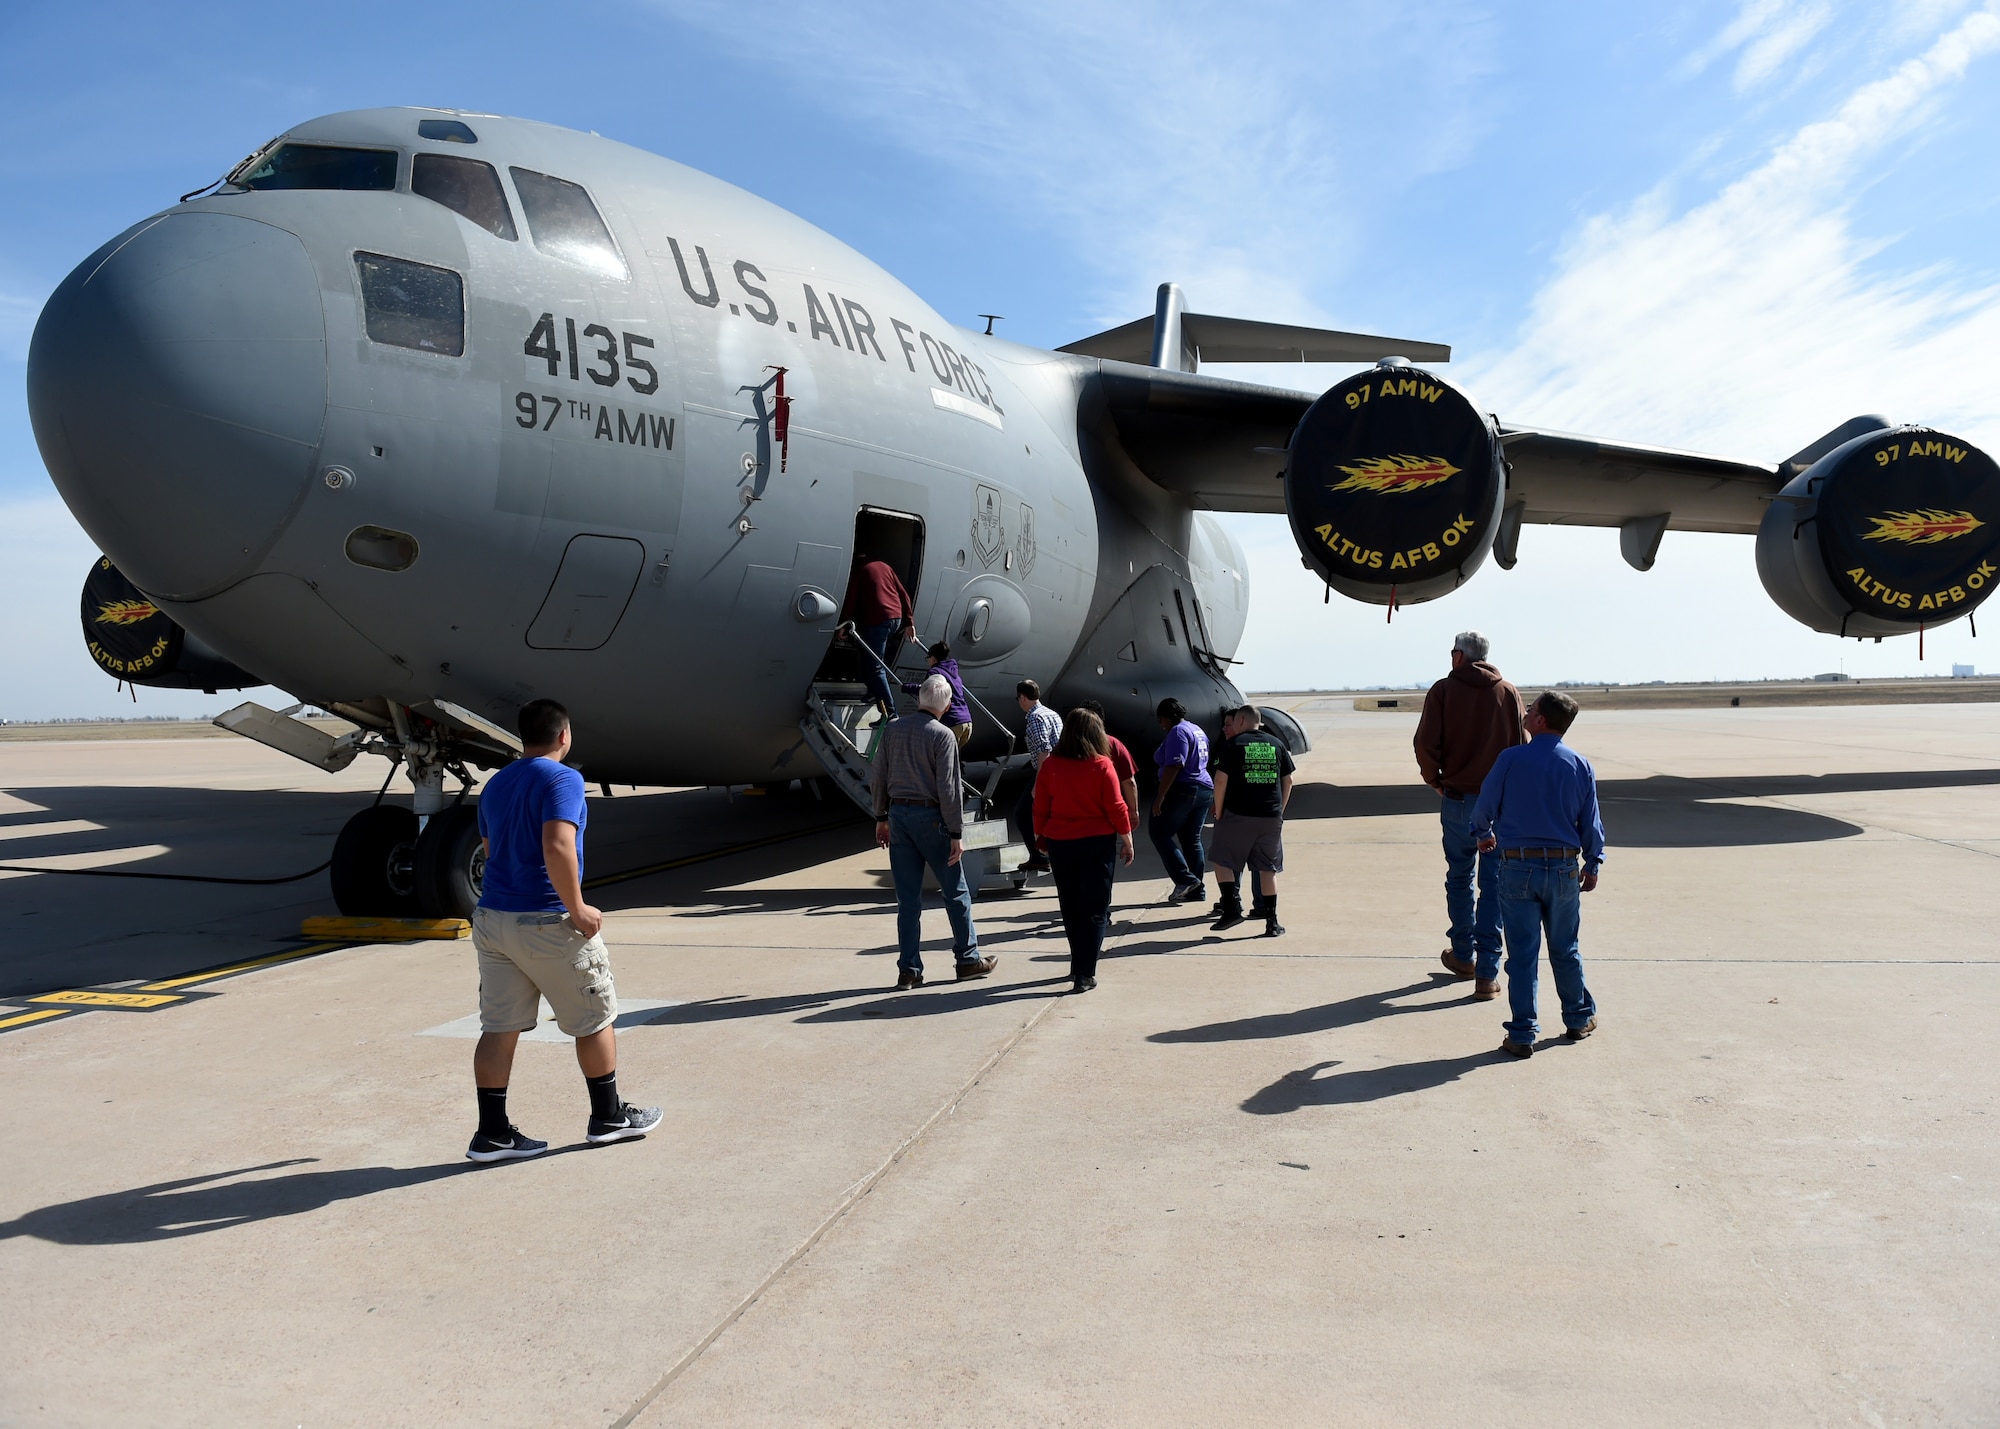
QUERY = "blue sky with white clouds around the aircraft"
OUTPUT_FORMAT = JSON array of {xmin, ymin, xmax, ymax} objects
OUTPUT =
[{"xmin": 0, "ymin": 0, "xmax": 2000, "ymax": 719}]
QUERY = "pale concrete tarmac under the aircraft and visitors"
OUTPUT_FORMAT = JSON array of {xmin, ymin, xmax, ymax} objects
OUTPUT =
[{"xmin": 0, "ymin": 700, "xmax": 2000, "ymax": 1425}]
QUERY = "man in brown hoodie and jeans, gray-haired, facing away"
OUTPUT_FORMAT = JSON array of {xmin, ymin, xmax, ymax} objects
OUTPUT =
[{"xmin": 1414, "ymin": 630, "xmax": 1528, "ymax": 1001}]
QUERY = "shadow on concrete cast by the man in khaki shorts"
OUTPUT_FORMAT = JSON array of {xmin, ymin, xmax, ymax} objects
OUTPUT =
[{"xmin": 0, "ymin": 1147, "xmax": 520, "ymax": 1245}]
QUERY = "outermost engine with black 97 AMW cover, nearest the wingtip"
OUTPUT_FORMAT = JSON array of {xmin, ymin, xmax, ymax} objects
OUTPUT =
[{"xmin": 1756, "ymin": 426, "xmax": 2000, "ymax": 636}]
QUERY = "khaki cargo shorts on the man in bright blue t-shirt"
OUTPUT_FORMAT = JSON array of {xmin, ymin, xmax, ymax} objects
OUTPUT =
[{"xmin": 472, "ymin": 909, "xmax": 618, "ymax": 1037}]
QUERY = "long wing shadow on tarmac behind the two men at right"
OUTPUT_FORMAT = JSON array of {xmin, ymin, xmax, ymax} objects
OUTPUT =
[{"xmin": 1286, "ymin": 769, "xmax": 2000, "ymax": 849}]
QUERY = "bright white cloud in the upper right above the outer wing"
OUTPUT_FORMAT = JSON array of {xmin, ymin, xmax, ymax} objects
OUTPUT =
[{"xmin": 1466, "ymin": 6, "xmax": 2000, "ymax": 458}]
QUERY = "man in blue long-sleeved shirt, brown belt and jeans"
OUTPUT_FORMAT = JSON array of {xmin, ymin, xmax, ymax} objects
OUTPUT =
[{"xmin": 1472, "ymin": 690, "xmax": 1604, "ymax": 1057}]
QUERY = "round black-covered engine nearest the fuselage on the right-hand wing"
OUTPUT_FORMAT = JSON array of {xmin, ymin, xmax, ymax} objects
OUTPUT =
[{"xmin": 1284, "ymin": 362, "xmax": 1506, "ymax": 604}]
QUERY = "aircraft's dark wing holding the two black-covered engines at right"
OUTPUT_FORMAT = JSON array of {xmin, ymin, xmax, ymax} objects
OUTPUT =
[{"xmin": 1098, "ymin": 362, "xmax": 1784, "ymax": 534}]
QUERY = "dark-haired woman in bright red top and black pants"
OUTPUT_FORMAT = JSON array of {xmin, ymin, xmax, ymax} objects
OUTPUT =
[{"xmin": 1034, "ymin": 710, "xmax": 1132, "ymax": 993}]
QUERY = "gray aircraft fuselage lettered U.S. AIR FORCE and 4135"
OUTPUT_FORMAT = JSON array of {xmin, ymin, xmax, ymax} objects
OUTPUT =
[{"xmin": 30, "ymin": 108, "xmax": 1248, "ymax": 785}]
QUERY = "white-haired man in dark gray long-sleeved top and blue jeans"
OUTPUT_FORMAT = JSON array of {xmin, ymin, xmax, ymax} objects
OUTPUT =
[{"xmin": 868, "ymin": 674, "xmax": 1000, "ymax": 993}]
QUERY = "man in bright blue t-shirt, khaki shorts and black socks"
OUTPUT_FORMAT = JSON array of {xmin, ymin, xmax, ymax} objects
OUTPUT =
[{"xmin": 466, "ymin": 700, "xmax": 660, "ymax": 1161}]
